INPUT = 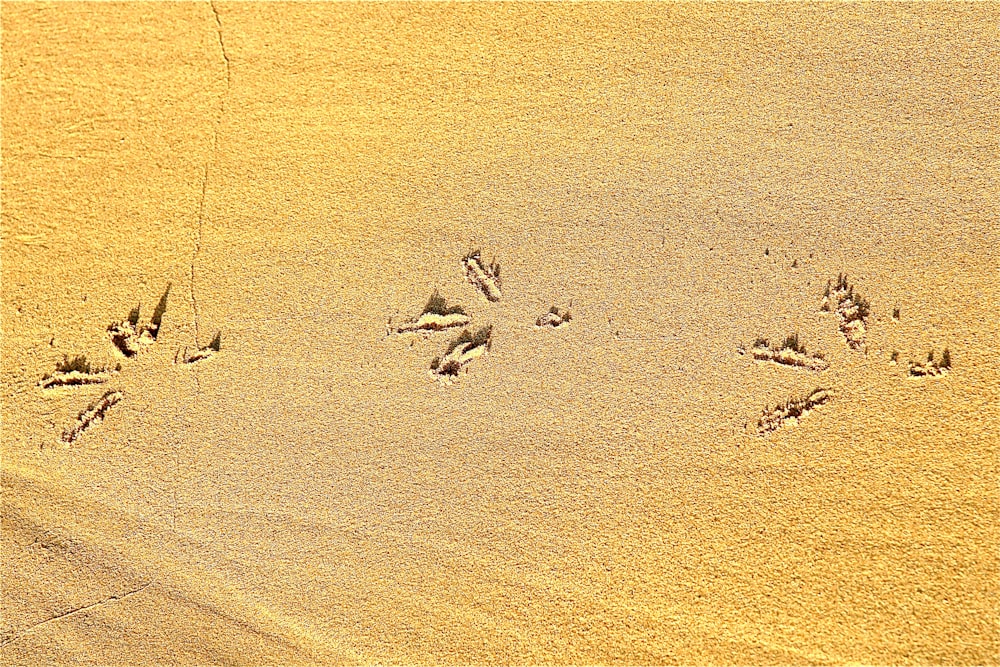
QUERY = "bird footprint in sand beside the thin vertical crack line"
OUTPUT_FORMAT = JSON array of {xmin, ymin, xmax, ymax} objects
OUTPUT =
[{"xmin": 38, "ymin": 284, "xmax": 222, "ymax": 446}]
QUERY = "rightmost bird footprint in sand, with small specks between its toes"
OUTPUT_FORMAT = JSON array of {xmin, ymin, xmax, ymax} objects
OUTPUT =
[{"xmin": 737, "ymin": 274, "xmax": 951, "ymax": 436}]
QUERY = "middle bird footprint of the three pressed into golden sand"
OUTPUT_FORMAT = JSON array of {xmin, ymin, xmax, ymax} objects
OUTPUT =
[{"xmin": 386, "ymin": 250, "xmax": 572, "ymax": 384}]
